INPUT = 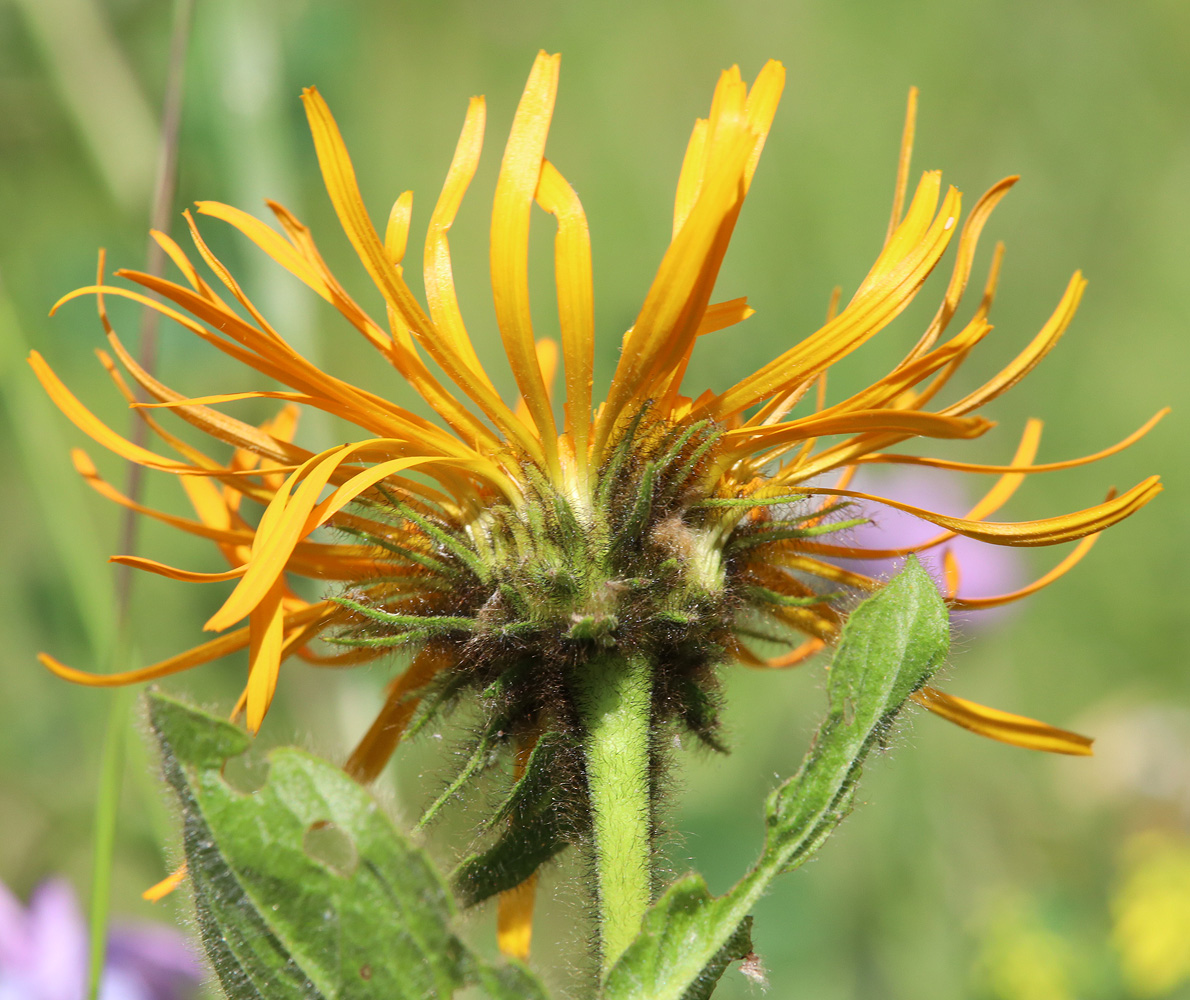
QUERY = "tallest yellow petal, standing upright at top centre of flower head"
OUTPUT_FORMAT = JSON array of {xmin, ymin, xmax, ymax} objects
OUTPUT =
[{"xmin": 491, "ymin": 52, "xmax": 562, "ymax": 481}]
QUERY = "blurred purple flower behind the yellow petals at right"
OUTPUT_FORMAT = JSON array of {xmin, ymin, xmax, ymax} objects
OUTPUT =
[{"xmin": 837, "ymin": 469, "xmax": 1026, "ymax": 626}]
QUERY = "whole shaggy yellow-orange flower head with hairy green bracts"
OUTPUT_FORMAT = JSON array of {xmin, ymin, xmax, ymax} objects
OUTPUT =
[{"xmin": 31, "ymin": 54, "xmax": 1161, "ymax": 779}]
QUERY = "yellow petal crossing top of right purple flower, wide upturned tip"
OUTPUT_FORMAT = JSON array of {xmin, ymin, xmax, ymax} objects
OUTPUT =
[{"xmin": 793, "ymin": 476, "xmax": 1163, "ymax": 548}]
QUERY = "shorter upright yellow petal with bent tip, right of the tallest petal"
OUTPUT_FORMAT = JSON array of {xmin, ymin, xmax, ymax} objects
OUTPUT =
[{"xmin": 537, "ymin": 160, "xmax": 595, "ymax": 481}]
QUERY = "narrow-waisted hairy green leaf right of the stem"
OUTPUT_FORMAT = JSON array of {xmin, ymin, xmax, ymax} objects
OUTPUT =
[{"xmin": 603, "ymin": 558, "xmax": 950, "ymax": 1000}]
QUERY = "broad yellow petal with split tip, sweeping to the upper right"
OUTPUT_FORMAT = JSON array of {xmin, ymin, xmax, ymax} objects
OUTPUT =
[{"xmin": 700, "ymin": 174, "xmax": 960, "ymax": 419}]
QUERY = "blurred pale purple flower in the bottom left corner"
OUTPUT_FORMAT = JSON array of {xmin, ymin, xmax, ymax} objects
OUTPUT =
[{"xmin": 0, "ymin": 879, "xmax": 203, "ymax": 1000}]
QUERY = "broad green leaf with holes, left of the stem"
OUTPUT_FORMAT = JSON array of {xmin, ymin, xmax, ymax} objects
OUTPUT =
[{"xmin": 149, "ymin": 693, "xmax": 545, "ymax": 1000}]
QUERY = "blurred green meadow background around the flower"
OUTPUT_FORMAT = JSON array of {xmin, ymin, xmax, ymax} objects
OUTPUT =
[{"xmin": 0, "ymin": 0, "xmax": 1190, "ymax": 1000}]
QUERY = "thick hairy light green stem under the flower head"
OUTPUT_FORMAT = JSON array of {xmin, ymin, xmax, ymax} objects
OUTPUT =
[{"xmin": 575, "ymin": 652, "xmax": 652, "ymax": 973}]
